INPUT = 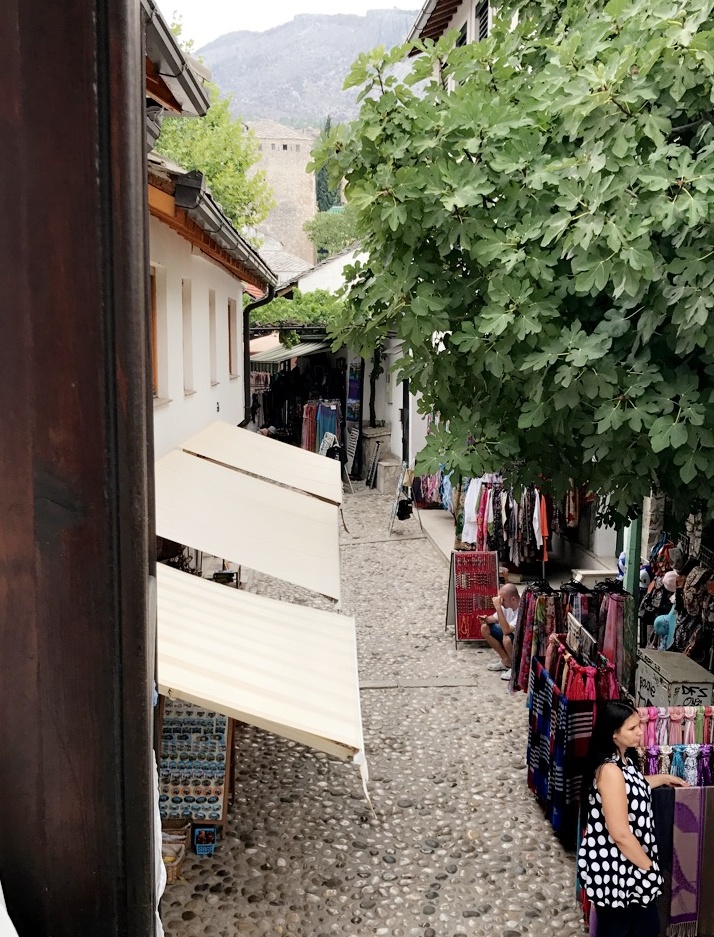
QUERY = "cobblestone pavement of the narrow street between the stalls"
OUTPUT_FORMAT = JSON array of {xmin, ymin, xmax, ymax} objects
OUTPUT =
[{"xmin": 163, "ymin": 485, "xmax": 583, "ymax": 937}]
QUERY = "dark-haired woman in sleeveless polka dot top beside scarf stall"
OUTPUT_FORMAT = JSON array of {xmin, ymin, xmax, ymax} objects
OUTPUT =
[{"xmin": 578, "ymin": 702, "xmax": 686, "ymax": 937}]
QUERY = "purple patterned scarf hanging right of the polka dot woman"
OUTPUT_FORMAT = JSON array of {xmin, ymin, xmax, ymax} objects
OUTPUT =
[{"xmin": 668, "ymin": 788, "xmax": 704, "ymax": 937}]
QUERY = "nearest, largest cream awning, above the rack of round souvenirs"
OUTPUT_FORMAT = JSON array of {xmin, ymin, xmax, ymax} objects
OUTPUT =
[{"xmin": 157, "ymin": 564, "xmax": 367, "ymax": 781}]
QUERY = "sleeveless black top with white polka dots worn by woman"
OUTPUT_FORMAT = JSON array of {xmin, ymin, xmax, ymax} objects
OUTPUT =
[{"xmin": 578, "ymin": 757, "xmax": 662, "ymax": 908}]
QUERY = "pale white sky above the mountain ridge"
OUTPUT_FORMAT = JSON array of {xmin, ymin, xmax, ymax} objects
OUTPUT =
[{"xmin": 159, "ymin": 0, "xmax": 423, "ymax": 49}]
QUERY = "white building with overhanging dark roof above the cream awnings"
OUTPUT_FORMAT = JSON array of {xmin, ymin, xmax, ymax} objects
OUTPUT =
[{"xmin": 148, "ymin": 153, "xmax": 276, "ymax": 459}]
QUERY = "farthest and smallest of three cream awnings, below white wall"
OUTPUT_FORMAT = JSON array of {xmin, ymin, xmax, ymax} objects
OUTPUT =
[{"xmin": 181, "ymin": 421, "xmax": 342, "ymax": 504}]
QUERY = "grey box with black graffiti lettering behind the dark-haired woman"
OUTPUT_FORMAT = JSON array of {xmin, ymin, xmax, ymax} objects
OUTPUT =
[{"xmin": 635, "ymin": 648, "xmax": 714, "ymax": 706}]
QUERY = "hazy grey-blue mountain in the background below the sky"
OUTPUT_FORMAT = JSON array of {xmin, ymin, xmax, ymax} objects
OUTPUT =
[{"xmin": 199, "ymin": 10, "xmax": 417, "ymax": 127}]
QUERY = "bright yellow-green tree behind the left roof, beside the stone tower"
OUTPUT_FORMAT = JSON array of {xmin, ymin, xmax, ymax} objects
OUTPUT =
[{"xmin": 156, "ymin": 85, "xmax": 275, "ymax": 230}]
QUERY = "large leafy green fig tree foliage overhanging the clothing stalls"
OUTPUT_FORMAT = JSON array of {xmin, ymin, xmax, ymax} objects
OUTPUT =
[{"xmin": 316, "ymin": 0, "xmax": 714, "ymax": 519}]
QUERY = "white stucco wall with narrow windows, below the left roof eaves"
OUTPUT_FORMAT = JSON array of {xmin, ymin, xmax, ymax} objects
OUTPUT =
[{"xmin": 149, "ymin": 218, "xmax": 244, "ymax": 459}]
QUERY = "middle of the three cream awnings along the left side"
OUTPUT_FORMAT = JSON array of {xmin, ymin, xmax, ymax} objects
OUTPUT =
[{"xmin": 155, "ymin": 446, "xmax": 341, "ymax": 601}]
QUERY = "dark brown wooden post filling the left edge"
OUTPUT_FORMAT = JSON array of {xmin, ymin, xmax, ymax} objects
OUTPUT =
[{"xmin": 0, "ymin": 0, "xmax": 154, "ymax": 937}]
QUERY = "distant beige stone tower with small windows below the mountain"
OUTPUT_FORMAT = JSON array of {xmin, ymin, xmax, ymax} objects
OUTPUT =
[{"xmin": 248, "ymin": 120, "xmax": 317, "ymax": 265}]
